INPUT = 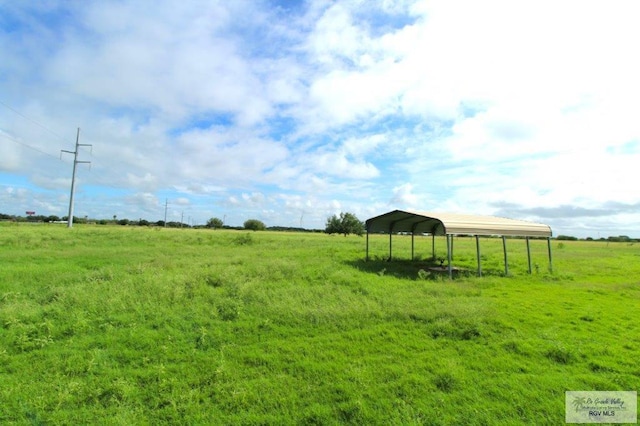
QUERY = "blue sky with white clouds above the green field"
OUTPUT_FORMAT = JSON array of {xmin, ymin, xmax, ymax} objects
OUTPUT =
[{"xmin": 0, "ymin": 0, "xmax": 640, "ymax": 238}]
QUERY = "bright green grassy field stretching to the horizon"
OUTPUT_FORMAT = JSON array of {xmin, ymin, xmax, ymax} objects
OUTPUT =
[{"xmin": 0, "ymin": 224, "xmax": 640, "ymax": 425}]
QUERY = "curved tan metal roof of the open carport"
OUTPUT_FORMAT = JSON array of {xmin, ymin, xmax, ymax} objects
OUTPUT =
[{"xmin": 365, "ymin": 210, "xmax": 552, "ymax": 237}]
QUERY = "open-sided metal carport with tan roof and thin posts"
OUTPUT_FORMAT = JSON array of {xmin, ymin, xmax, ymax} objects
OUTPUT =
[{"xmin": 365, "ymin": 210, "xmax": 553, "ymax": 277}]
